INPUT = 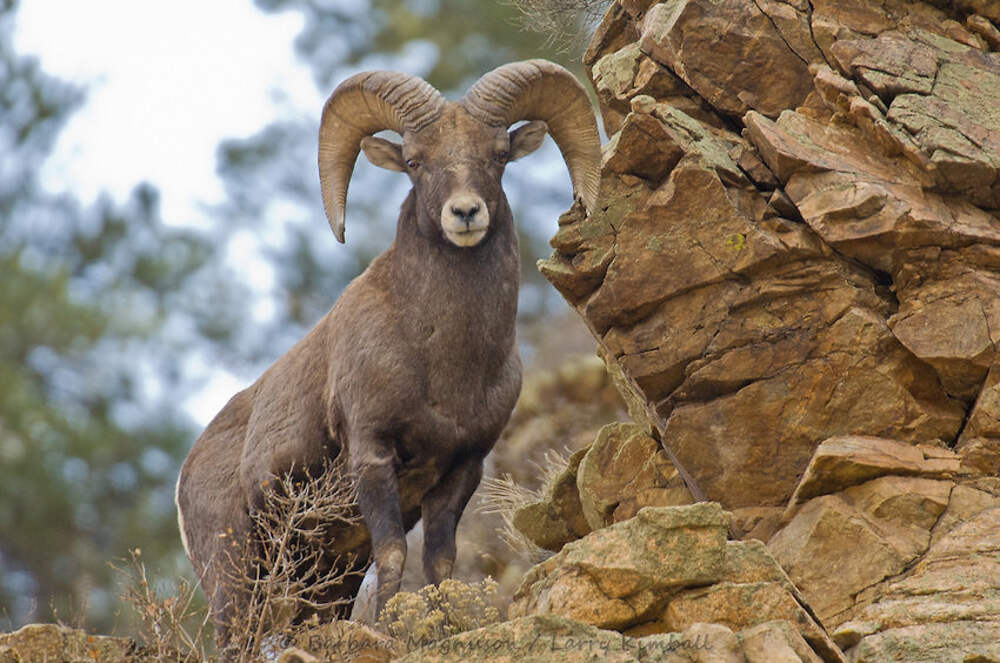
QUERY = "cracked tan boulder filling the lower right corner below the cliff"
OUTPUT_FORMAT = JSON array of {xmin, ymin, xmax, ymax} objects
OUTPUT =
[{"xmin": 767, "ymin": 438, "xmax": 1000, "ymax": 663}]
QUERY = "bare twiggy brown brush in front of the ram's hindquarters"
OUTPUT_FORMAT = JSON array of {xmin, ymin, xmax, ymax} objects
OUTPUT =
[{"xmin": 116, "ymin": 462, "xmax": 365, "ymax": 663}]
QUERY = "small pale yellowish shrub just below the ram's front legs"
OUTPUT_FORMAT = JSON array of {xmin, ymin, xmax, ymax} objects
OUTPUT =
[{"xmin": 378, "ymin": 578, "xmax": 501, "ymax": 651}]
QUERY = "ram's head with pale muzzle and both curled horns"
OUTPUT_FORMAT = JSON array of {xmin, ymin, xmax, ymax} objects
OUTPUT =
[{"xmin": 319, "ymin": 60, "xmax": 600, "ymax": 247}]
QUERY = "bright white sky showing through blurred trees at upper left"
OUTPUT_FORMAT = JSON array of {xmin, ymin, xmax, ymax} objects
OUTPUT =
[{"xmin": 14, "ymin": 0, "xmax": 323, "ymax": 425}]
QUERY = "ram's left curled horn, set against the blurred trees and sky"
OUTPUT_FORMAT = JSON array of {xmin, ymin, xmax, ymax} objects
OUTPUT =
[{"xmin": 319, "ymin": 71, "xmax": 445, "ymax": 242}]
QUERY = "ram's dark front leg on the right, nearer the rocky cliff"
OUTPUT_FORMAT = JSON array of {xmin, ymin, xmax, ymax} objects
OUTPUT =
[{"xmin": 420, "ymin": 456, "xmax": 483, "ymax": 585}]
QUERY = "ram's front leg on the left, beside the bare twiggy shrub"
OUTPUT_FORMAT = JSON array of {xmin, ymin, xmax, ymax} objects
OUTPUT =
[{"xmin": 356, "ymin": 456, "xmax": 406, "ymax": 618}]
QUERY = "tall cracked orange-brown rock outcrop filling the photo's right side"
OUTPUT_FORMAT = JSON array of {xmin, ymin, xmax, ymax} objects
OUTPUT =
[{"xmin": 536, "ymin": 0, "xmax": 1000, "ymax": 661}]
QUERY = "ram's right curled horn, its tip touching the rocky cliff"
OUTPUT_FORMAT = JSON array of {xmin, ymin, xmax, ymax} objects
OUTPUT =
[{"xmin": 461, "ymin": 60, "xmax": 601, "ymax": 210}]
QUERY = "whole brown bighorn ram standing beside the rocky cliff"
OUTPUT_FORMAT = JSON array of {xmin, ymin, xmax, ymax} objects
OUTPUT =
[{"xmin": 177, "ymin": 60, "xmax": 600, "ymax": 640}]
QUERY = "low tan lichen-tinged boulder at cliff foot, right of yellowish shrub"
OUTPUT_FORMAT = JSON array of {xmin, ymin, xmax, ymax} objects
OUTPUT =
[{"xmin": 509, "ymin": 503, "xmax": 844, "ymax": 661}]
